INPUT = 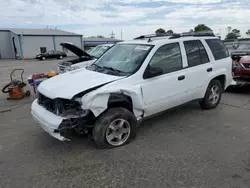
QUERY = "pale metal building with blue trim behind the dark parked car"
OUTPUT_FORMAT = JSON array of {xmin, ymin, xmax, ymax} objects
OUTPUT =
[{"xmin": 0, "ymin": 29, "xmax": 84, "ymax": 59}]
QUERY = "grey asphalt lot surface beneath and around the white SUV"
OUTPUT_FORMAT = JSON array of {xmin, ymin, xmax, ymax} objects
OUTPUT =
[{"xmin": 0, "ymin": 61, "xmax": 250, "ymax": 188}]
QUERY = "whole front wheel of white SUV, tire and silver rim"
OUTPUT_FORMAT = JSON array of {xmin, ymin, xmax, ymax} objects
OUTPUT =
[{"xmin": 93, "ymin": 108, "xmax": 137, "ymax": 148}]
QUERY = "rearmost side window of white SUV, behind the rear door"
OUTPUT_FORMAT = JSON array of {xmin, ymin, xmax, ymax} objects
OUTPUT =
[{"xmin": 206, "ymin": 39, "xmax": 229, "ymax": 60}]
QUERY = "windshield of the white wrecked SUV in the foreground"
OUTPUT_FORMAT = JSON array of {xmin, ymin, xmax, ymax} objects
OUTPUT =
[{"xmin": 92, "ymin": 44, "xmax": 152, "ymax": 76}]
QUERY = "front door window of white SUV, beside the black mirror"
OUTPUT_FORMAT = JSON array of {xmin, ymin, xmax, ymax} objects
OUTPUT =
[{"xmin": 149, "ymin": 43, "xmax": 183, "ymax": 74}]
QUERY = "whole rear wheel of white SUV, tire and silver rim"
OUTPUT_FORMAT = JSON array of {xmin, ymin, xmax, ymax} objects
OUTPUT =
[{"xmin": 200, "ymin": 80, "xmax": 223, "ymax": 110}]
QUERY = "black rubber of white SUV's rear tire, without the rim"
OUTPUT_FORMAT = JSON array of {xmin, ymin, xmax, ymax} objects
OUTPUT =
[{"xmin": 200, "ymin": 80, "xmax": 223, "ymax": 110}]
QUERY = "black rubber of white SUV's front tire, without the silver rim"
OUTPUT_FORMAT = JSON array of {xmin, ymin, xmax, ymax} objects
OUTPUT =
[{"xmin": 93, "ymin": 108, "xmax": 137, "ymax": 149}]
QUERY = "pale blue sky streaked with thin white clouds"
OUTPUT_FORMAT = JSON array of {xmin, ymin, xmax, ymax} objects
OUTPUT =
[{"xmin": 0, "ymin": 0, "xmax": 250, "ymax": 39}]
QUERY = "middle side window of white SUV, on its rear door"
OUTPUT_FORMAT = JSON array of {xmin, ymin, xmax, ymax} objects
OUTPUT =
[{"xmin": 184, "ymin": 40, "xmax": 209, "ymax": 67}]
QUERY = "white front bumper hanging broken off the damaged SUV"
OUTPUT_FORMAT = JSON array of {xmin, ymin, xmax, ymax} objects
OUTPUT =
[{"xmin": 31, "ymin": 99, "xmax": 69, "ymax": 141}]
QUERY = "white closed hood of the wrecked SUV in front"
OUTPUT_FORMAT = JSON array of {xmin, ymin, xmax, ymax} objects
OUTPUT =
[{"xmin": 38, "ymin": 68, "xmax": 122, "ymax": 99}]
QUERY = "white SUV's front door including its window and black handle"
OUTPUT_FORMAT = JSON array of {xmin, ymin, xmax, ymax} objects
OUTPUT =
[{"xmin": 142, "ymin": 42, "xmax": 187, "ymax": 116}]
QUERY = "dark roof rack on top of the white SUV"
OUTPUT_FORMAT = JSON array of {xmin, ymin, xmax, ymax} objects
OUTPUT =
[{"xmin": 134, "ymin": 31, "xmax": 215, "ymax": 42}]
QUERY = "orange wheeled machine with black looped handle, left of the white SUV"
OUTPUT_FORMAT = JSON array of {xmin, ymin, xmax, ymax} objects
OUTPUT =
[{"xmin": 2, "ymin": 69, "xmax": 30, "ymax": 100}]
